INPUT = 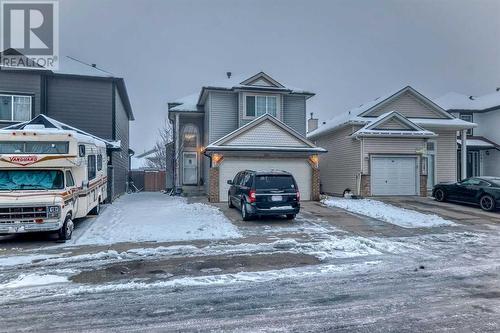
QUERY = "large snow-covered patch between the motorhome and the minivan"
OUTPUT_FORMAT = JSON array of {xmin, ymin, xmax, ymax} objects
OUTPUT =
[{"xmin": 72, "ymin": 192, "xmax": 240, "ymax": 245}]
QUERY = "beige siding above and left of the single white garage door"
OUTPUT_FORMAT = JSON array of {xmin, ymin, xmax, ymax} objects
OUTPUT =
[{"xmin": 362, "ymin": 138, "xmax": 425, "ymax": 174}]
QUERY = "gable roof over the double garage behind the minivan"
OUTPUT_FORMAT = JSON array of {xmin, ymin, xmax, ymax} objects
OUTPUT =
[{"xmin": 206, "ymin": 114, "xmax": 326, "ymax": 153}]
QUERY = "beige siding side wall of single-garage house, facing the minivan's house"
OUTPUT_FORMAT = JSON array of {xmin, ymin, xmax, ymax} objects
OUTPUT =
[{"xmin": 316, "ymin": 126, "xmax": 361, "ymax": 194}]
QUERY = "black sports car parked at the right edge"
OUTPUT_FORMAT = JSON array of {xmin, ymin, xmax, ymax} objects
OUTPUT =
[{"xmin": 432, "ymin": 177, "xmax": 500, "ymax": 212}]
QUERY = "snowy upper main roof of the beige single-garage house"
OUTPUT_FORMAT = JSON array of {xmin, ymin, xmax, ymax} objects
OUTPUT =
[{"xmin": 307, "ymin": 86, "xmax": 476, "ymax": 139}]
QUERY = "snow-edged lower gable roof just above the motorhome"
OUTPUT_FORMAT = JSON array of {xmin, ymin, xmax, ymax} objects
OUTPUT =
[{"xmin": 0, "ymin": 114, "xmax": 121, "ymax": 150}]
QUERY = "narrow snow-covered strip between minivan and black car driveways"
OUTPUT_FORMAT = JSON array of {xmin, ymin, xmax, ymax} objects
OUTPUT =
[{"xmin": 322, "ymin": 197, "xmax": 456, "ymax": 228}]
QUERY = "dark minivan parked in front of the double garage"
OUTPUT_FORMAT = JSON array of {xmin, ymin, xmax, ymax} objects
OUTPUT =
[{"xmin": 227, "ymin": 170, "xmax": 300, "ymax": 221}]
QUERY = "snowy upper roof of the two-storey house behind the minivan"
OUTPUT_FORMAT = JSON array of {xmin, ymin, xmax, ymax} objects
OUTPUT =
[{"xmin": 169, "ymin": 72, "xmax": 314, "ymax": 112}]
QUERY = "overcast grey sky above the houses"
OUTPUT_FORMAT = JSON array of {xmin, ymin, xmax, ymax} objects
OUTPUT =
[{"xmin": 60, "ymin": 0, "xmax": 500, "ymax": 152}]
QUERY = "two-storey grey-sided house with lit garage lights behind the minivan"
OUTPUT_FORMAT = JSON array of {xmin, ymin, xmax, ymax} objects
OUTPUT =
[{"xmin": 169, "ymin": 72, "xmax": 324, "ymax": 202}]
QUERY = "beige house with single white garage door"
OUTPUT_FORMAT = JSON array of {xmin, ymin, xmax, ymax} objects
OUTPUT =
[{"xmin": 307, "ymin": 86, "xmax": 474, "ymax": 196}]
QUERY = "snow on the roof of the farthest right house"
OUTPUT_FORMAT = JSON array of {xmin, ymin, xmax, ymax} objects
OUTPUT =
[{"xmin": 434, "ymin": 91, "xmax": 500, "ymax": 111}]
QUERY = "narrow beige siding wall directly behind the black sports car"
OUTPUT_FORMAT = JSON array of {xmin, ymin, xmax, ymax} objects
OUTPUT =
[{"xmin": 430, "ymin": 128, "xmax": 457, "ymax": 183}]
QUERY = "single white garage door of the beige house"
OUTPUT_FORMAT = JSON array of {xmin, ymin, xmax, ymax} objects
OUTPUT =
[{"xmin": 371, "ymin": 157, "xmax": 418, "ymax": 195}]
